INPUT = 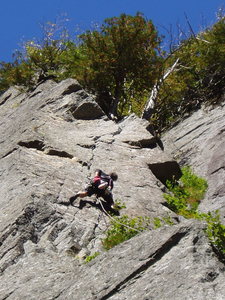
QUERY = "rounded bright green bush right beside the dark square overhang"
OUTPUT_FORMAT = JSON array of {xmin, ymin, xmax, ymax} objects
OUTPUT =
[{"xmin": 164, "ymin": 167, "xmax": 208, "ymax": 218}]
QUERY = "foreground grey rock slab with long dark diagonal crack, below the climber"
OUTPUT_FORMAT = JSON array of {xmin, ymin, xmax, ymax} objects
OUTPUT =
[{"xmin": 1, "ymin": 221, "xmax": 224, "ymax": 300}]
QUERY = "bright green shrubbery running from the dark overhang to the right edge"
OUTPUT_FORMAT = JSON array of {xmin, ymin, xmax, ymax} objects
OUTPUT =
[{"xmin": 163, "ymin": 167, "xmax": 225, "ymax": 262}]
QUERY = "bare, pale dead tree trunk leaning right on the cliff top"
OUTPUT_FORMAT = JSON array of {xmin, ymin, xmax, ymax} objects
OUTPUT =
[{"xmin": 141, "ymin": 58, "xmax": 179, "ymax": 120}]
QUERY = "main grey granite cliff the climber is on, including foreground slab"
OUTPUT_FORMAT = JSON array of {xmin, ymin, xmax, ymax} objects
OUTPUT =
[{"xmin": 0, "ymin": 79, "xmax": 225, "ymax": 300}]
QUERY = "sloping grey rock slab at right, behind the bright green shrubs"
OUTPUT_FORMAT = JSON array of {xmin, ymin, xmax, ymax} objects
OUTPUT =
[{"xmin": 163, "ymin": 103, "xmax": 225, "ymax": 219}]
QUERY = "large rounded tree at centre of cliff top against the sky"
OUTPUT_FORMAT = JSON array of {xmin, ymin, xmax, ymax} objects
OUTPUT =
[{"xmin": 80, "ymin": 13, "xmax": 160, "ymax": 116}]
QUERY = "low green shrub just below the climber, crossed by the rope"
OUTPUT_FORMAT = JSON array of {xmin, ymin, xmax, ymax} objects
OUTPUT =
[{"xmin": 102, "ymin": 215, "xmax": 149, "ymax": 250}]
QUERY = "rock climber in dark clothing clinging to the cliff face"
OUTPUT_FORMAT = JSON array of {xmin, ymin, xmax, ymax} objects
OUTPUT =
[{"xmin": 70, "ymin": 169, "xmax": 118, "ymax": 209}]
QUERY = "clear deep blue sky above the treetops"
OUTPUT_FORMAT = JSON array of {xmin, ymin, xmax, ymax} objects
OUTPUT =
[{"xmin": 0, "ymin": 0, "xmax": 225, "ymax": 61}]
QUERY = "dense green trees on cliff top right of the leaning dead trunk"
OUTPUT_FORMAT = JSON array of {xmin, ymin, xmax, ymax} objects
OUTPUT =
[{"xmin": 151, "ymin": 15, "xmax": 225, "ymax": 132}]
